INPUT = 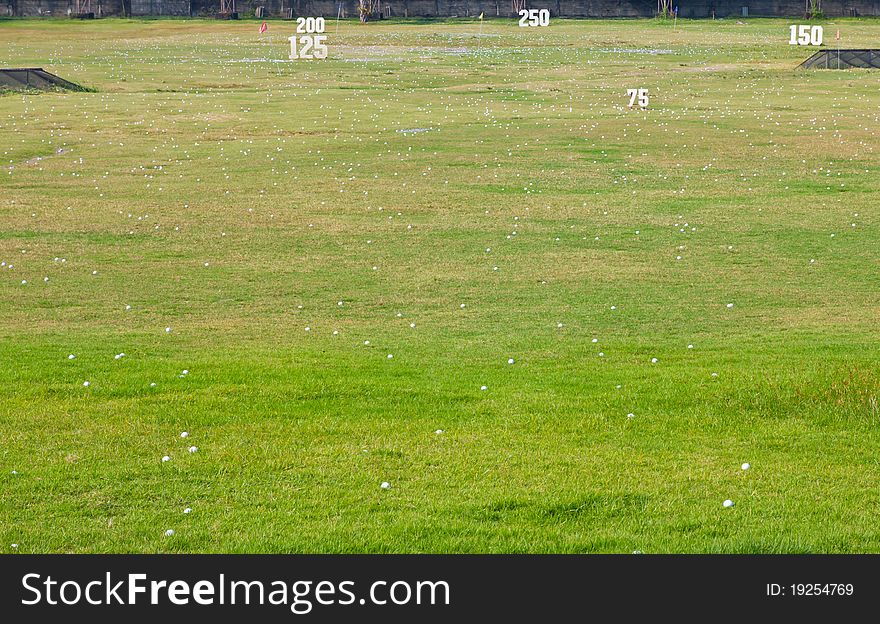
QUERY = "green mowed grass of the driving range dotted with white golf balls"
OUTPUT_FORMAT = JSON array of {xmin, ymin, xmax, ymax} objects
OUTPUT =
[{"xmin": 0, "ymin": 19, "xmax": 880, "ymax": 553}]
